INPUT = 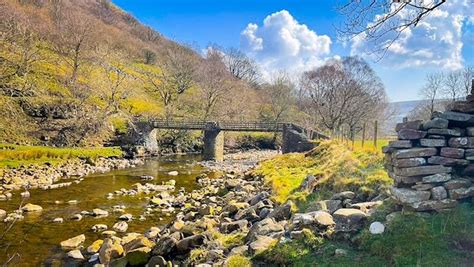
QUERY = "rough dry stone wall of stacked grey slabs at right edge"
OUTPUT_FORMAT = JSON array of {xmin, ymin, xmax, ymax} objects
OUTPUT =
[{"xmin": 384, "ymin": 88, "xmax": 474, "ymax": 211}]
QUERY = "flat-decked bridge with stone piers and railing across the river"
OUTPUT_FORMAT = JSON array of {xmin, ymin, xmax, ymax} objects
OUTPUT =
[{"xmin": 131, "ymin": 120, "xmax": 328, "ymax": 161}]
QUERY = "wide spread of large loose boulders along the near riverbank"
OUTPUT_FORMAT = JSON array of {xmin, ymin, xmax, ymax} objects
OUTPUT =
[{"xmin": 51, "ymin": 152, "xmax": 390, "ymax": 266}]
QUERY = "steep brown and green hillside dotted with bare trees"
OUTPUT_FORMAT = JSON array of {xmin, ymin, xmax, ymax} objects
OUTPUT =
[{"xmin": 0, "ymin": 0, "xmax": 258, "ymax": 146}]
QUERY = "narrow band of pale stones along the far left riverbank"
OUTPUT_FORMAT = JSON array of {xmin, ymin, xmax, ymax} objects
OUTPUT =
[{"xmin": 0, "ymin": 158, "xmax": 143, "ymax": 200}]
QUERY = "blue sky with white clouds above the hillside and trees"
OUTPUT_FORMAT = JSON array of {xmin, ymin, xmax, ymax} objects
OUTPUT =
[{"xmin": 113, "ymin": 0, "xmax": 474, "ymax": 101}]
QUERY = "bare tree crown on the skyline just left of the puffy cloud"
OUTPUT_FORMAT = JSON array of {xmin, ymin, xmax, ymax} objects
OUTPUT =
[{"xmin": 223, "ymin": 48, "xmax": 260, "ymax": 85}]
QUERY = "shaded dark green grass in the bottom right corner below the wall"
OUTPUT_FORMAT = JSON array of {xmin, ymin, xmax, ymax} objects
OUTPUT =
[{"xmin": 253, "ymin": 204, "xmax": 474, "ymax": 267}]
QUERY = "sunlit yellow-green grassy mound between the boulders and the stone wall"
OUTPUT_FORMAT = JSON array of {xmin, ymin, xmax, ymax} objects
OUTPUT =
[{"xmin": 254, "ymin": 141, "xmax": 392, "ymax": 204}]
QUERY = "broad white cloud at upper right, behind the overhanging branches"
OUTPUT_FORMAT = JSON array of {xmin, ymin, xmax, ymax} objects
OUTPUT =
[{"xmin": 351, "ymin": 0, "xmax": 474, "ymax": 70}]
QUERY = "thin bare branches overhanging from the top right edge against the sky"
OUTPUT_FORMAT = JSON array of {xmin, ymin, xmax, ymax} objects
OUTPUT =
[{"xmin": 337, "ymin": 0, "xmax": 446, "ymax": 53}]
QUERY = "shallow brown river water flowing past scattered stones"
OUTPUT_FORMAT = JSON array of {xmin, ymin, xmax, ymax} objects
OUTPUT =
[{"xmin": 0, "ymin": 155, "xmax": 213, "ymax": 266}]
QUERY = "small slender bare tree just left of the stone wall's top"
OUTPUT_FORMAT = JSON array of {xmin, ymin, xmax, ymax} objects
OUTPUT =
[{"xmin": 420, "ymin": 72, "xmax": 444, "ymax": 118}]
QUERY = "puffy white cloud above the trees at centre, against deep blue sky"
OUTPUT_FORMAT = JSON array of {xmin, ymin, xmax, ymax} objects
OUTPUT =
[{"xmin": 240, "ymin": 10, "xmax": 331, "ymax": 80}]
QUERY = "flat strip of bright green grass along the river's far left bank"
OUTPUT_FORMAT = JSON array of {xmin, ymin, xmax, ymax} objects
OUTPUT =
[{"xmin": 0, "ymin": 144, "xmax": 123, "ymax": 168}]
